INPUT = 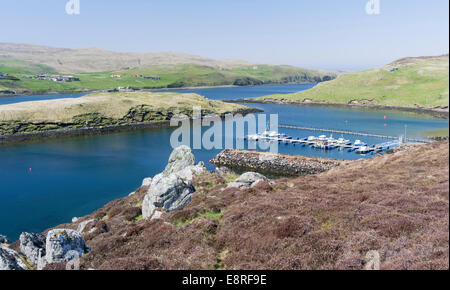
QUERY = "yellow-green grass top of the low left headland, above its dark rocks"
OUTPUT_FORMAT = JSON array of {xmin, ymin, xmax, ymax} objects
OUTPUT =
[{"xmin": 0, "ymin": 92, "xmax": 246, "ymax": 123}]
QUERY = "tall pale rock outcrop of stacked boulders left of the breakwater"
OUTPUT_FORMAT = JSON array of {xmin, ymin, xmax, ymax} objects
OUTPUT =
[{"xmin": 142, "ymin": 146, "xmax": 206, "ymax": 219}]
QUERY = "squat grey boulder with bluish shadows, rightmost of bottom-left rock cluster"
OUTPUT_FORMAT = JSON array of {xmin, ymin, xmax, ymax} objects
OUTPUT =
[{"xmin": 45, "ymin": 229, "xmax": 89, "ymax": 264}]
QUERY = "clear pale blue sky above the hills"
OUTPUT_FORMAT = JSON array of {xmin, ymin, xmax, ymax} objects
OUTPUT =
[{"xmin": 0, "ymin": 0, "xmax": 449, "ymax": 70}]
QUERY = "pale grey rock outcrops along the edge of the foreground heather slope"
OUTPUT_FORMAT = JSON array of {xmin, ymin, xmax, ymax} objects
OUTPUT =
[{"xmin": 0, "ymin": 145, "xmax": 273, "ymax": 270}]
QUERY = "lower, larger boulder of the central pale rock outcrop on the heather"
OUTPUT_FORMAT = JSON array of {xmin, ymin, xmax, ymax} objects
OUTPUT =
[{"xmin": 142, "ymin": 174, "xmax": 195, "ymax": 219}]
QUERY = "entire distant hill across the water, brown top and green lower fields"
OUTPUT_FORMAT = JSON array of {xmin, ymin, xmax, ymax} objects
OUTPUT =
[{"xmin": 0, "ymin": 43, "xmax": 336, "ymax": 94}]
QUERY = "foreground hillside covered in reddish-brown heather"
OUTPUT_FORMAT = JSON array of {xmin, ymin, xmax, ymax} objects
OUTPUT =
[{"xmin": 17, "ymin": 142, "xmax": 449, "ymax": 270}]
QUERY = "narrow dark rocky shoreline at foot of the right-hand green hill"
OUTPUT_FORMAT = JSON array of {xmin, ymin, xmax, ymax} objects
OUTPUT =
[{"xmin": 222, "ymin": 98, "xmax": 449, "ymax": 119}]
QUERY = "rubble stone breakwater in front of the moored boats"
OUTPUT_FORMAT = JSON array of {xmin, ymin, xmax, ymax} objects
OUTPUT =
[{"xmin": 210, "ymin": 149, "xmax": 342, "ymax": 176}]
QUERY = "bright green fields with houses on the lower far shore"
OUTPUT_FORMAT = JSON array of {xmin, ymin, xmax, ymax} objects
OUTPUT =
[{"xmin": 0, "ymin": 60, "xmax": 335, "ymax": 93}]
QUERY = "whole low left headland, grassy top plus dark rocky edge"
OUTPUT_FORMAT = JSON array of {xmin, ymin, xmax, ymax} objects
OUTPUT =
[{"xmin": 0, "ymin": 92, "xmax": 247, "ymax": 135}]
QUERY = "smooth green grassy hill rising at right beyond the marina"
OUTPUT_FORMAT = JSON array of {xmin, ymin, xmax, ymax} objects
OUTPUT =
[{"xmin": 261, "ymin": 55, "xmax": 449, "ymax": 108}]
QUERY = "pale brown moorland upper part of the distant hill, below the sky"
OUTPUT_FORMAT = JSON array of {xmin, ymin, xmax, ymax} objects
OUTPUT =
[{"xmin": 0, "ymin": 43, "xmax": 253, "ymax": 73}]
